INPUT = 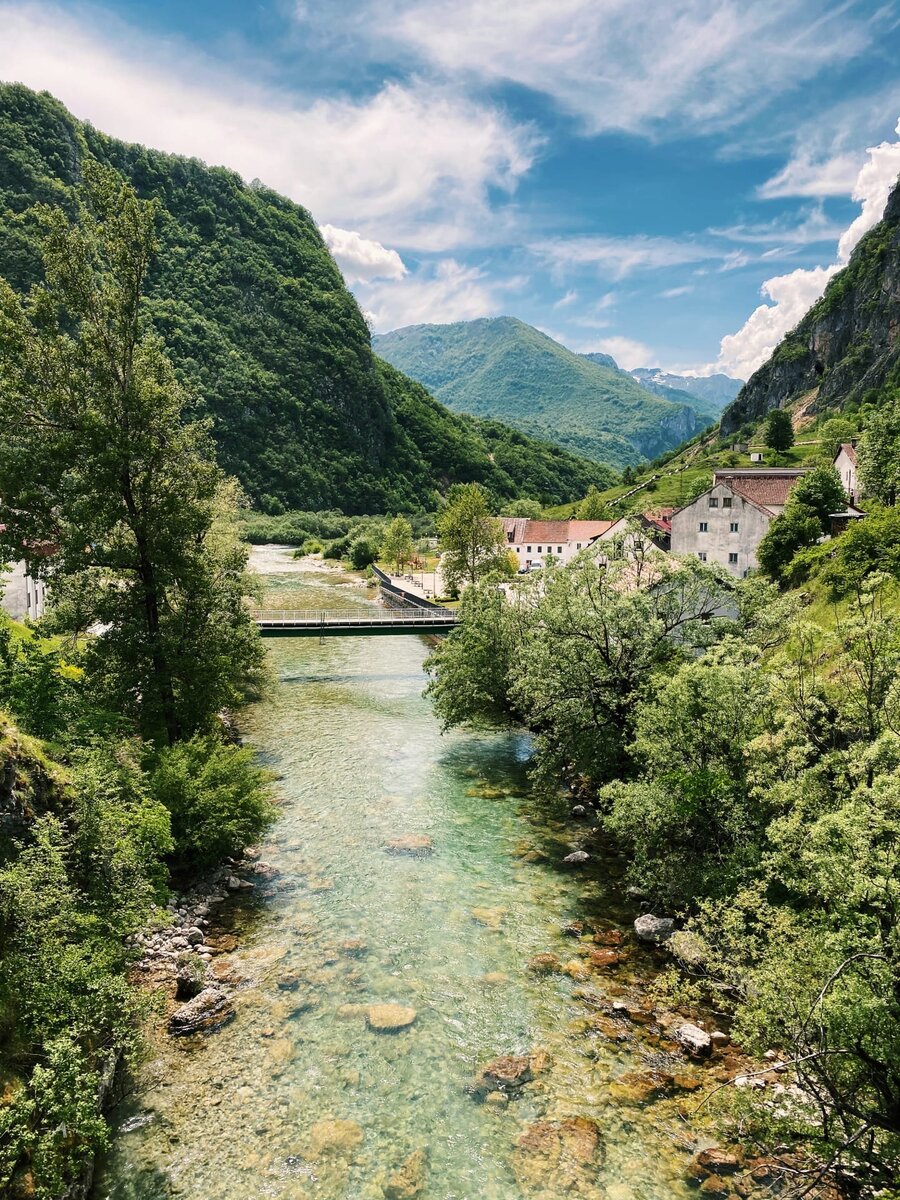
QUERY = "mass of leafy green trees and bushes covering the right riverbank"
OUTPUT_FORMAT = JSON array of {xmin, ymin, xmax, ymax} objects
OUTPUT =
[{"xmin": 430, "ymin": 560, "xmax": 900, "ymax": 1188}]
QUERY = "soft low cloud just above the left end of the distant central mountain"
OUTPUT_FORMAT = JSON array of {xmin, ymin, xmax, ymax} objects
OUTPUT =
[{"xmin": 355, "ymin": 258, "xmax": 508, "ymax": 334}]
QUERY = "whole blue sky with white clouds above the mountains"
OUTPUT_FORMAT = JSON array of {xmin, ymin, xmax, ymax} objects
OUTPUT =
[{"xmin": 0, "ymin": 0, "xmax": 900, "ymax": 378}]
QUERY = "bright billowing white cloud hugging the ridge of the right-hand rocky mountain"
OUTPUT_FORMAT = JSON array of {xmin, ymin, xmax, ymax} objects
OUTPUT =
[{"xmin": 702, "ymin": 121, "xmax": 900, "ymax": 378}]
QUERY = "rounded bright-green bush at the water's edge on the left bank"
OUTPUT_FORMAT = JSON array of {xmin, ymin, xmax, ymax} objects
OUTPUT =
[{"xmin": 150, "ymin": 737, "xmax": 275, "ymax": 868}]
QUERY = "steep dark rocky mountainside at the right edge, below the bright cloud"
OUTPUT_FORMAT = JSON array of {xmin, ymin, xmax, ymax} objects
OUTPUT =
[{"xmin": 721, "ymin": 174, "xmax": 900, "ymax": 433}]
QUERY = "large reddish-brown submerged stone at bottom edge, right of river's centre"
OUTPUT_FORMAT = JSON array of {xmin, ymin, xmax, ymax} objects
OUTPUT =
[{"xmin": 512, "ymin": 1117, "xmax": 602, "ymax": 1200}]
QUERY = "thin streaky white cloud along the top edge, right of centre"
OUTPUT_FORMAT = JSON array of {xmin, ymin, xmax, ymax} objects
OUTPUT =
[{"xmin": 362, "ymin": 0, "xmax": 889, "ymax": 134}]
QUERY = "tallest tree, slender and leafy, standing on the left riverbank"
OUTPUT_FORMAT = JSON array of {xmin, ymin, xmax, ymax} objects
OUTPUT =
[{"xmin": 0, "ymin": 162, "xmax": 262, "ymax": 743}]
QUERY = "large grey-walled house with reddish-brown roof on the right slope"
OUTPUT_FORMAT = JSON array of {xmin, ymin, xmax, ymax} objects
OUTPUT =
[{"xmin": 671, "ymin": 467, "xmax": 809, "ymax": 578}]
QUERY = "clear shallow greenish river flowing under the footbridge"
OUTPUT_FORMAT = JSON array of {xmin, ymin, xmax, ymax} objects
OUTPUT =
[{"xmin": 95, "ymin": 547, "xmax": 710, "ymax": 1200}]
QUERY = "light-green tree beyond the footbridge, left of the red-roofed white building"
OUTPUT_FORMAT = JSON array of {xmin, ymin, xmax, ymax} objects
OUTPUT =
[{"xmin": 437, "ymin": 484, "xmax": 506, "ymax": 593}]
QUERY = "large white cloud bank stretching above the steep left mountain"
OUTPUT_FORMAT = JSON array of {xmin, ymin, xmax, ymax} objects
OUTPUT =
[{"xmin": 0, "ymin": 2, "xmax": 536, "ymax": 251}]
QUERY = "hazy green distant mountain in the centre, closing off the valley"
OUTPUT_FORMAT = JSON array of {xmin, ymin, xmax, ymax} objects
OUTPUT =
[{"xmin": 373, "ymin": 317, "xmax": 708, "ymax": 467}]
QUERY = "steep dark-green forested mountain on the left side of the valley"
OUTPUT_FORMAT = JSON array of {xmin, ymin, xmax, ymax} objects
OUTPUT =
[{"xmin": 0, "ymin": 85, "xmax": 611, "ymax": 514}]
